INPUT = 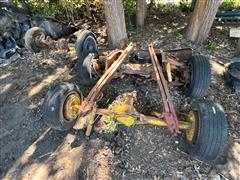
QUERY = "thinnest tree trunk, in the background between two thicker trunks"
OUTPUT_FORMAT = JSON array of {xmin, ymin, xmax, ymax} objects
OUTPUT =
[{"xmin": 136, "ymin": 0, "xmax": 147, "ymax": 27}]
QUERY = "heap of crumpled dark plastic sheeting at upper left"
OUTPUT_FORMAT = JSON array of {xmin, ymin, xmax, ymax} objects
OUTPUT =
[{"xmin": 0, "ymin": 1, "xmax": 74, "ymax": 67}]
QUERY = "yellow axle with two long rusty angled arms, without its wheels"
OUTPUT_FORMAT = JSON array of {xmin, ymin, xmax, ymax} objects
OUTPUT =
[{"xmin": 74, "ymin": 43, "xmax": 192, "ymax": 136}]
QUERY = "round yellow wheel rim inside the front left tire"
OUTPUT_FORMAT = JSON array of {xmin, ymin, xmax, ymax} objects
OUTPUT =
[{"xmin": 63, "ymin": 93, "xmax": 81, "ymax": 121}]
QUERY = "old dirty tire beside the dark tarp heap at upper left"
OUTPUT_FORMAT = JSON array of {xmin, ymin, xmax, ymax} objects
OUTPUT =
[{"xmin": 24, "ymin": 27, "xmax": 45, "ymax": 53}]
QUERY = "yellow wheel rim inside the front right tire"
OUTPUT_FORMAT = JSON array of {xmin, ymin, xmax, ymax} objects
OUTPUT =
[{"xmin": 186, "ymin": 111, "xmax": 197, "ymax": 142}]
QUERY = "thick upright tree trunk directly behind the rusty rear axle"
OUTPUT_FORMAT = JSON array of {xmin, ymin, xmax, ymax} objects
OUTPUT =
[{"xmin": 103, "ymin": 0, "xmax": 127, "ymax": 48}]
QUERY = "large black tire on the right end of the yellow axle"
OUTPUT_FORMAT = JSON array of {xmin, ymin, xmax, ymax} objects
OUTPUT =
[{"xmin": 185, "ymin": 100, "xmax": 228, "ymax": 163}]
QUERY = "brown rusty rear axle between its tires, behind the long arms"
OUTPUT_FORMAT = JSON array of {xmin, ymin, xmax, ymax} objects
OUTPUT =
[{"xmin": 91, "ymin": 48, "xmax": 192, "ymax": 85}]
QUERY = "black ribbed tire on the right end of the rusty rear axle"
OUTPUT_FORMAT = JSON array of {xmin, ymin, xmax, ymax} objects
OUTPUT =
[{"xmin": 185, "ymin": 55, "xmax": 211, "ymax": 97}]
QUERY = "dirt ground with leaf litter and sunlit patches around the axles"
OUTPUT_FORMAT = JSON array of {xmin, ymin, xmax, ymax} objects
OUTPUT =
[{"xmin": 0, "ymin": 15, "xmax": 240, "ymax": 180}]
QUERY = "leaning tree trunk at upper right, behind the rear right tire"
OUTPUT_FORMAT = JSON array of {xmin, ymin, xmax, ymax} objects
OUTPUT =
[{"xmin": 186, "ymin": 0, "xmax": 221, "ymax": 44}]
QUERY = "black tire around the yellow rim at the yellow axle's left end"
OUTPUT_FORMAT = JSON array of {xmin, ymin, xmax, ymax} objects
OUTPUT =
[{"xmin": 42, "ymin": 83, "xmax": 82, "ymax": 131}]
